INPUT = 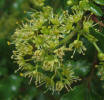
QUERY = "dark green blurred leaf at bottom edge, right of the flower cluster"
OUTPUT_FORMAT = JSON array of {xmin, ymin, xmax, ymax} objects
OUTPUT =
[{"xmin": 61, "ymin": 84, "xmax": 102, "ymax": 100}]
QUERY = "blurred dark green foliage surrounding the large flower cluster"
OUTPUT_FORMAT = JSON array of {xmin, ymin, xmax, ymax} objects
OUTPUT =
[{"xmin": 0, "ymin": 0, "xmax": 104, "ymax": 100}]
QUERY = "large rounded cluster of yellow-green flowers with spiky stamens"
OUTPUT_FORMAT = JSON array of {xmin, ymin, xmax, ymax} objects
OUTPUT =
[{"xmin": 12, "ymin": 0, "xmax": 101, "ymax": 92}]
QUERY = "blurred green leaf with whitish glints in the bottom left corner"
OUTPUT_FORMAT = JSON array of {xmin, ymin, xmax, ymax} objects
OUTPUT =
[{"xmin": 0, "ymin": 75, "xmax": 22, "ymax": 100}]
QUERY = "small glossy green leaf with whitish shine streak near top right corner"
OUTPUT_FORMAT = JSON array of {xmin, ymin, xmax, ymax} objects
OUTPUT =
[{"xmin": 90, "ymin": 3, "xmax": 103, "ymax": 16}]
